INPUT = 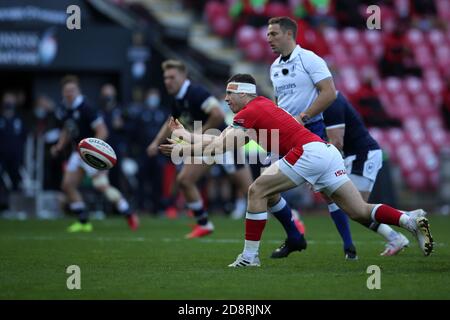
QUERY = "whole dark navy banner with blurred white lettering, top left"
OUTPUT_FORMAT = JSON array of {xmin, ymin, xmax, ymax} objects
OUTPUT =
[{"xmin": 0, "ymin": 0, "xmax": 131, "ymax": 71}]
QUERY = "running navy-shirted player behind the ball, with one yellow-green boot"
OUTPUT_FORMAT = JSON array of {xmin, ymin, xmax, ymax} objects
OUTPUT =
[{"xmin": 52, "ymin": 75, "xmax": 139, "ymax": 232}]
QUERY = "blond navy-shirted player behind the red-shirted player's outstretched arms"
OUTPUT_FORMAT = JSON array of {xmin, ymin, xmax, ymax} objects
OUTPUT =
[{"xmin": 147, "ymin": 60, "xmax": 252, "ymax": 238}]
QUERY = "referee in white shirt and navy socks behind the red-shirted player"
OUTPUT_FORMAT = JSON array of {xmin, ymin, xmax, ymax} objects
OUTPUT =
[{"xmin": 267, "ymin": 17, "xmax": 357, "ymax": 260}]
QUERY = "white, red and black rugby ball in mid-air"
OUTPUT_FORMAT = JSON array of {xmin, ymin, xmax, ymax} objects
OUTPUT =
[{"xmin": 78, "ymin": 138, "xmax": 117, "ymax": 170}]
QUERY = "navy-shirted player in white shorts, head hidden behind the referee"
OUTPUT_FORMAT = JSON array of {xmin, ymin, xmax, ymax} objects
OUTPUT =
[{"xmin": 323, "ymin": 92, "xmax": 409, "ymax": 256}]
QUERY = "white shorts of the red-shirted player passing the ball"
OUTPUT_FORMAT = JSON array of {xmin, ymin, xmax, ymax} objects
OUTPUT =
[{"xmin": 278, "ymin": 142, "xmax": 350, "ymax": 196}]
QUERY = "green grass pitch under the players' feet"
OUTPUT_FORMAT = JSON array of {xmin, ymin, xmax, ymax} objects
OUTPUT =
[{"xmin": 0, "ymin": 214, "xmax": 450, "ymax": 300}]
